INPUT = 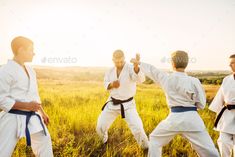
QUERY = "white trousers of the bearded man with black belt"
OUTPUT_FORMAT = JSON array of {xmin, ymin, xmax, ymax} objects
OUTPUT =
[{"xmin": 96, "ymin": 106, "xmax": 148, "ymax": 149}]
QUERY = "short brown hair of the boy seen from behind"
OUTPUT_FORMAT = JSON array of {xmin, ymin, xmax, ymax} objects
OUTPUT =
[{"xmin": 171, "ymin": 50, "xmax": 189, "ymax": 69}]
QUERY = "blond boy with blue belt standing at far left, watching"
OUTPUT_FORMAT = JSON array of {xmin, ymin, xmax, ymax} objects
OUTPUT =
[{"xmin": 0, "ymin": 36, "xmax": 53, "ymax": 157}]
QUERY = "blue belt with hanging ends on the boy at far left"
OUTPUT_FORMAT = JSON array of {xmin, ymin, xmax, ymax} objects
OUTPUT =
[{"xmin": 8, "ymin": 109, "xmax": 47, "ymax": 146}]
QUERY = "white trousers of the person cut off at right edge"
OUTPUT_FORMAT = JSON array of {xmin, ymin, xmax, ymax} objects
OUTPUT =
[{"xmin": 217, "ymin": 132, "xmax": 235, "ymax": 157}]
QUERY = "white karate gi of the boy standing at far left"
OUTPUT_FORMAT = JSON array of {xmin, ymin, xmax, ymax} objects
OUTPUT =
[{"xmin": 0, "ymin": 60, "xmax": 53, "ymax": 157}]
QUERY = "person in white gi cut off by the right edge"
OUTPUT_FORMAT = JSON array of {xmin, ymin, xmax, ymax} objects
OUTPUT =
[{"xmin": 209, "ymin": 54, "xmax": 235, "ymax": 157}]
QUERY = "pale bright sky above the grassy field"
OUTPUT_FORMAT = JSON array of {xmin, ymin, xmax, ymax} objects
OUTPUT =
[{"xmin": 0, "ymin": 0, "xmax": 235, "ymax": 70}]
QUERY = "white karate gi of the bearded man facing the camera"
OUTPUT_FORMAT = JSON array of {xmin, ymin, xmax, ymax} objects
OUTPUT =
[{"xmin": 96, "ymin": 63, "xmax": 148, "ymax": 148}]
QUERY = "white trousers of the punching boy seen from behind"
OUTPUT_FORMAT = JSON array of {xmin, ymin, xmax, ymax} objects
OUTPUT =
[{"xmin": 148, "ymin": 125, "xmax": 219, "ymax": 157}]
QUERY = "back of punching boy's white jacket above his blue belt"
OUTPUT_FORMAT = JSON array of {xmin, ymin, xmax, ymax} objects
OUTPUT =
[{"xmin": 163, "ymin": 72, "xmax": 205, "ymax": 108}]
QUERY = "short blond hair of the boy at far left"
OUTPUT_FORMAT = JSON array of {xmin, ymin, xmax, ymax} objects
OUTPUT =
[{"xmin": 11, "ymin": 36, "xmax": 33, "ymax": 55}]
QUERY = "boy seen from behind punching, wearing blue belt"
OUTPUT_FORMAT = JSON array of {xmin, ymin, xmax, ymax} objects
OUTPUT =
[{"xmin": 131, "ymin": 51, "xmax": 219, "ymax": 157}]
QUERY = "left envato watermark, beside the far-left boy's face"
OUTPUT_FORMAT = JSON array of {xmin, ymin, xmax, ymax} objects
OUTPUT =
[{"xmin": 41, "ymin": 56, "xmax": 78, "ymax": 64}]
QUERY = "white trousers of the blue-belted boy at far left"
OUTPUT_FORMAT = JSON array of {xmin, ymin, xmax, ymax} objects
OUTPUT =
[{"xmin": 0, "ymin": 114, "xmax": 53, "ymax": 157}]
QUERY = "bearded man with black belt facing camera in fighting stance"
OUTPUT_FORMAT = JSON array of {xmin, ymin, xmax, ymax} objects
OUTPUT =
[{"xmin": 96, "ymin": 50, "xmax": 148, "ymax": 149}]
